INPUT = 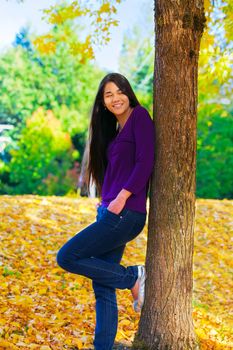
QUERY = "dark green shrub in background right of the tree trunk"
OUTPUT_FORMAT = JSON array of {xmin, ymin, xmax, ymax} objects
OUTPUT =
[{"xmin": 197, "ymin": 104, "xmax": 233, "ymax": 199}]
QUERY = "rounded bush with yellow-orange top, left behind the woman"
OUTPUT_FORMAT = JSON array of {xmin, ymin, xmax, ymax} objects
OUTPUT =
[{"xmin": 3, "ymin": 108, "xmax": 77, "ymax": 195}]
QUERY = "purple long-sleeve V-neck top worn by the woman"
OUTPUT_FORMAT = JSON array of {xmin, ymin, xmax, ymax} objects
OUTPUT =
[{"xmin": 101, "ymin": 105, "xmax": 155, "ymax": 213}]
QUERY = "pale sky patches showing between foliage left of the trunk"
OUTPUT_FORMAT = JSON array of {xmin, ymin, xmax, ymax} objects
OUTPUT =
[{"xmin": 0, "ymin": 0, "xmax": 153, "ymax": 71}]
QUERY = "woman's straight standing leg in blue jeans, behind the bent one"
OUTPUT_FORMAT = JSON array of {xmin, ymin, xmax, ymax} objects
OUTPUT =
[{"xmin": 92, "ymin": 245, "xmax": 125, "ymax": 350}]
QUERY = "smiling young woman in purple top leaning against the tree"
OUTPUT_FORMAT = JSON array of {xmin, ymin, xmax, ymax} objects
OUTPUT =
[{"xmin": 57, "ymin": 73, "xmax": 155, "ymax": 350}]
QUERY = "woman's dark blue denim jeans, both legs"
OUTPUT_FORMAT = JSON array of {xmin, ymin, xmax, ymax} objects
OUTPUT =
[{"xmin": 57, "ymin": 205, "xmax": 146, "ymax": 350}]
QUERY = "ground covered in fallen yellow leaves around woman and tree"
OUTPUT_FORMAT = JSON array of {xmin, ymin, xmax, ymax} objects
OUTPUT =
[{"xmin": 0, "ymin": 195, "xmax": 233, "ymax": 350}]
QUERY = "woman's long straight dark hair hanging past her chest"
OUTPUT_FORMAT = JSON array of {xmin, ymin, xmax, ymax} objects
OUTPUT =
[{"xmin": 86, "ymin": 73, "xmax": 139, "ymax": 196}]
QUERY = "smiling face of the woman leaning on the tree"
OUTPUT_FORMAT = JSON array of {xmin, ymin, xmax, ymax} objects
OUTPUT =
[{"xmin": 103, "ymin": 82, "xmax": 131, "ymax": 117}]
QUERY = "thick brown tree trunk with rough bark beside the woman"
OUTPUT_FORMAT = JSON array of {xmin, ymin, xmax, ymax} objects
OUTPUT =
[{"xmin": 133, "ymin": 0, "xmax": 205, "ymax": 350}]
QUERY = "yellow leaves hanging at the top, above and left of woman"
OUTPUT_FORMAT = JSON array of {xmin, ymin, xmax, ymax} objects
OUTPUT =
[{"xmin": 33, "ymin": 0, "xmax": 121, "ymax": 59}]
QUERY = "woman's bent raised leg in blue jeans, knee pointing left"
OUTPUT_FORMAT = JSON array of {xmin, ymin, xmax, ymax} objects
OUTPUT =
[{"xmin": 57, "ymin": 209, "xmax": 146, "ymax": 289}]
